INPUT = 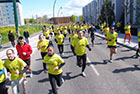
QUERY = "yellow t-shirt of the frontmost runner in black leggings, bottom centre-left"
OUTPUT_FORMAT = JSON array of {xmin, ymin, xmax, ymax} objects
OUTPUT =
[{"xmin": 43, "ymin": 54, "xmax": 64, "ymax": 75}]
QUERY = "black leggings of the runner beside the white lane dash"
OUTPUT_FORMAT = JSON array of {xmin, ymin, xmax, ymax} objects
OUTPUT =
[{"xmin": 77, "ymin": 54, "xmax": 87, "ymax": 72}]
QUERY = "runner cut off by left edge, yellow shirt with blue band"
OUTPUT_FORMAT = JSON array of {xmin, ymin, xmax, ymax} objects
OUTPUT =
[{"xmin": 0, "ymin": 59, "xmax": 8, "ymax": 94}]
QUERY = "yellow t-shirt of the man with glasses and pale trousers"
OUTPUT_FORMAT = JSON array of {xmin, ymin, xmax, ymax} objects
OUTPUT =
[{"xmin": 4, "ymin": 58, "xmax": 27, "ymax": 80}]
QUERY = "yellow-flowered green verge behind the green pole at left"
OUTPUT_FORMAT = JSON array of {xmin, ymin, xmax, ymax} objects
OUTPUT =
[{"xmin": 0, "ymin": 24, "xmax": 50, "ymax": 44}]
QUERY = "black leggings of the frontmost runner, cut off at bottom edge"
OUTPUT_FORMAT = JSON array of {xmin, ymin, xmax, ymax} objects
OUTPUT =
[{"xmin": 48, "ymin": 73, "xmax": 62, "ymax": 94}]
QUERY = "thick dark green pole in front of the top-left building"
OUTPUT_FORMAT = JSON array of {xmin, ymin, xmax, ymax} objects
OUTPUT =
[{"xmin": 13, "ymin": 0, "xmax": 19, "ymax": 37}]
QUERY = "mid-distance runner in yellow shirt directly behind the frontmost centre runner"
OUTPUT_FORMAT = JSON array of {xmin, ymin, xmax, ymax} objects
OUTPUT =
[{"xmin": 55, "ymin": 30, "xmax": 64, "ymax": 57}]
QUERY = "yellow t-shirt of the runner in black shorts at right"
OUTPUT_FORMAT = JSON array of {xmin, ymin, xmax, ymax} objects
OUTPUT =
[{"xmin": 106, "ymin": 32, "xmax": 118, "ymax": 46}]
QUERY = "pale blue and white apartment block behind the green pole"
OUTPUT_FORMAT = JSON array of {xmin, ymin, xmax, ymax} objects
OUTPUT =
[{"xmin": 0, "ymin": 0, "xmax": 24, "ymax": 27}]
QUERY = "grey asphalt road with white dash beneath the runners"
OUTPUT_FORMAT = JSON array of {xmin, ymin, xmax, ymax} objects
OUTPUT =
[{"xmin": 25, "ymin": 33, "xmax": 140, "ymax": 94}]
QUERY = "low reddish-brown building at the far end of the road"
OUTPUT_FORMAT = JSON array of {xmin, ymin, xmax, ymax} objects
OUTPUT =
[{"xmin": 49, "ymin": 17, "xmax": 71, "ymax": 24}]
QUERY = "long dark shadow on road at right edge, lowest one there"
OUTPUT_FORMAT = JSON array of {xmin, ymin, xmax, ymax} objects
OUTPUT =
[{"xmin": 112, "ymin": 65, "xmax": 140, "ymax": 73}]
